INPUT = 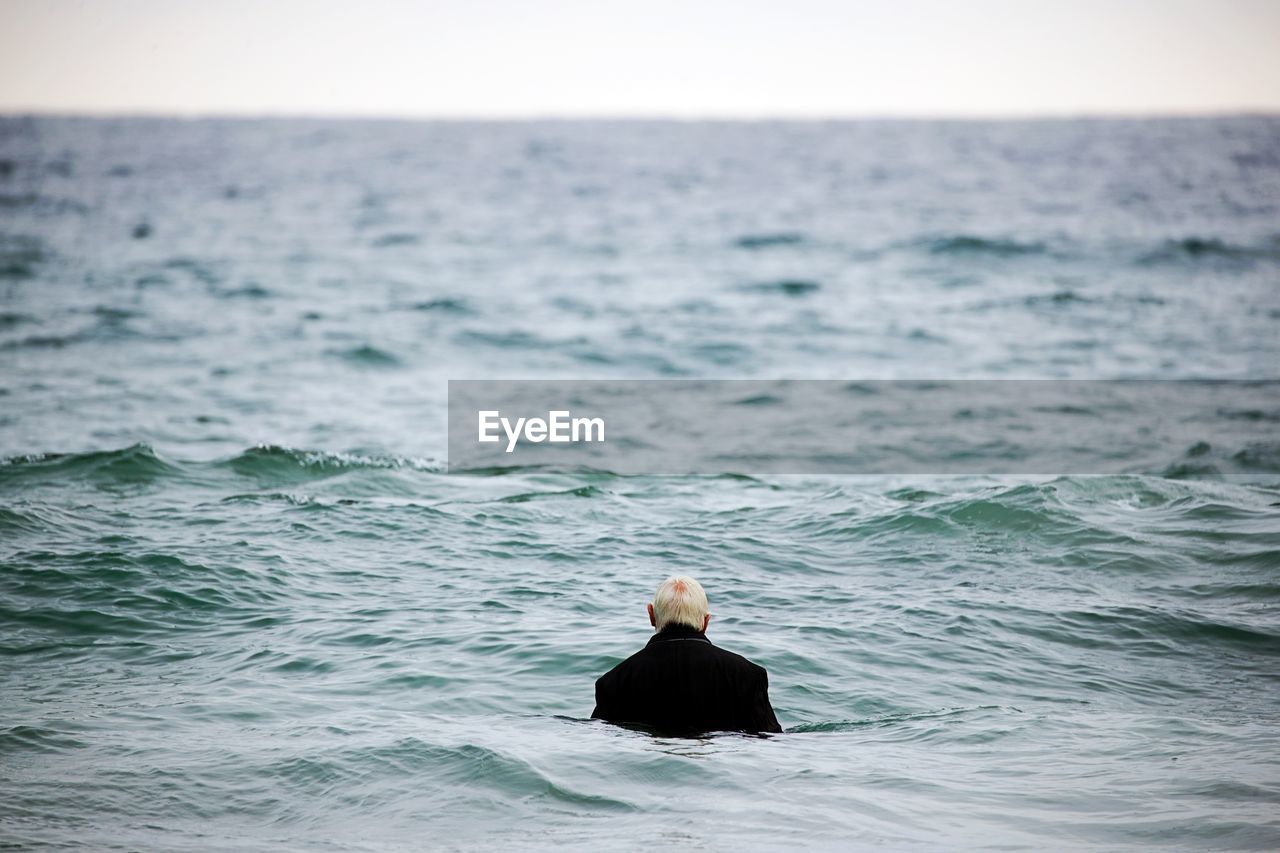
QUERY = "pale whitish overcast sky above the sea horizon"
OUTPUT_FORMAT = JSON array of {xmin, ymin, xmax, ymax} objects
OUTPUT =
[{"xmin": 0, "ymin": 0, "xmax": 1280, "ymax": 118}]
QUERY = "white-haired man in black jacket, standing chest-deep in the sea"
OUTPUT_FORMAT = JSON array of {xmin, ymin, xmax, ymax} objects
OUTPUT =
[{"xmin": 591, "ymin": 575, "xmax": 782, "ymax": 734}]
